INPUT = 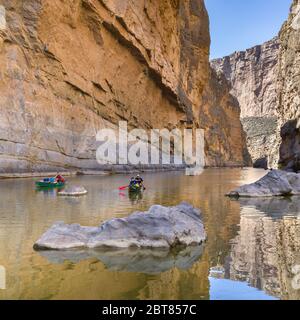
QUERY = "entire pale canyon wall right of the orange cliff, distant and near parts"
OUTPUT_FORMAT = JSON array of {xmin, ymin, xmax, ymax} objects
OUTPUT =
[{"xmin": 211, "ymin": 0, "xmax": 300, "ymax": 171}]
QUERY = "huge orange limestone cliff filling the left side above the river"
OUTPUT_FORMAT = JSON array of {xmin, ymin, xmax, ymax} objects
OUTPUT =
[{"xmin": 0, "ymin": 0, "xmax": 245, "ymax": 173}]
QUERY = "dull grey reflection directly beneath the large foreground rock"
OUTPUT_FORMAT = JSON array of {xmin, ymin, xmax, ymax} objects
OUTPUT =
[{"xmin": 36, "ymin": 246, "xmax": 203, "ymax": 274}]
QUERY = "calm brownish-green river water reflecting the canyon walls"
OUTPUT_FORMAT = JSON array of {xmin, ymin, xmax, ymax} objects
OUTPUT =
[{"xmin": 0, "ymin": 169, "xmax": 300, "ymax": 299}]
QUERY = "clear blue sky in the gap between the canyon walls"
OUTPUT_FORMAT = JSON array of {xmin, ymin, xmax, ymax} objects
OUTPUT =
[{"xmin": 205, "ymin": 0, "xmax": 292, "ymax": 59}]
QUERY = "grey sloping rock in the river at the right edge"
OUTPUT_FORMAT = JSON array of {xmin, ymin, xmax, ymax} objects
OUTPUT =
[{"xmin": 227, "ymin": 170, "xmax": 300, "ymax": 197}]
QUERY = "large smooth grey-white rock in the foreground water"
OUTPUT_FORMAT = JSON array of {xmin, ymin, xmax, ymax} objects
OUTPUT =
[{"xmin": 34, "ymin": 203, "xmax": 206, "ymax": 250}]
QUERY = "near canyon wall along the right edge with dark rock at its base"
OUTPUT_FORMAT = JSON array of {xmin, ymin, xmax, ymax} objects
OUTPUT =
[{"xmin": 276, "ymin": 0, "xmax": 300, "ymax": 171}]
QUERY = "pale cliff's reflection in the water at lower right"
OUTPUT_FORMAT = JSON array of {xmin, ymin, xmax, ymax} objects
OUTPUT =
[{"xmin": 225, "ymin": 197, "xmax": 300, "ymax": 299}]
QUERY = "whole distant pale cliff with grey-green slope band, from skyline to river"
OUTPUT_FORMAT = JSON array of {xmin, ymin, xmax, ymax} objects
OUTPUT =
[{"xmin": 211, "ymin": 38, "xmax": 279, "ymax": 167}]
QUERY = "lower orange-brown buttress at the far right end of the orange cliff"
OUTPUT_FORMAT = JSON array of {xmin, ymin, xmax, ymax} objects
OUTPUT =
[{"xmin": 200, "ymin": 69, "xmax": 251, "ymax": 167}]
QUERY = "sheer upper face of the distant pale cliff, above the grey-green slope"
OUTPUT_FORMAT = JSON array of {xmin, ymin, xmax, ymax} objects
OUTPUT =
[{"xmin": 211, "ymin": 38, "xmax": 279, "ymax": 118}]
